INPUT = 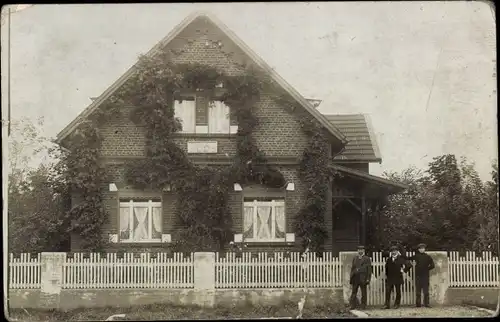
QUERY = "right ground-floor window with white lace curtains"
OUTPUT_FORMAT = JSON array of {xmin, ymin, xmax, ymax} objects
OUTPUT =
[{"xmin": 243, "ymin": 199, "xmax": 286, "ymax": 242}]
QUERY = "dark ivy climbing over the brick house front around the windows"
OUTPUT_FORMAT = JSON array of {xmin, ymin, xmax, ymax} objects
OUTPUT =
[{"xmin": 60, "ymin": 48, "xmax": 333, "ymax": 251}]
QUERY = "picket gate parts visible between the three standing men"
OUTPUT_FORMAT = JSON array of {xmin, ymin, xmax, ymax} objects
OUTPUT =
[{"xmin": 366, "ymin": 252, "xmax": 416, "ymax": 306}]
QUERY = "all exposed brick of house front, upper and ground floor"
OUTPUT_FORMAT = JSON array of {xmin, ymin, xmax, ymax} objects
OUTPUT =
[{"xmin": 71, "ymin": 17, "xmax": 332, "ymax": 251}]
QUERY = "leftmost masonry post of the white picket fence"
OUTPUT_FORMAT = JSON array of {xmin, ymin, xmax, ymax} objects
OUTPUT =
[{"xmin": 40, "ymin": 253, "xmax": 66, "ymax": 308}]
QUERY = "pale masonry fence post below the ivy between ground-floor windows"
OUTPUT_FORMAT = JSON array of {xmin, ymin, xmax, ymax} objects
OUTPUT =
[{"xmin": 193, "ymin": 252, "xmax": 215, "ymax": 307}]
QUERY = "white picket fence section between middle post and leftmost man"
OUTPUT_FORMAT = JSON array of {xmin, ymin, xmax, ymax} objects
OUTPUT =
[{"xmin": 215, "ymin": 252, "xmax": 342, "ymax": 289}]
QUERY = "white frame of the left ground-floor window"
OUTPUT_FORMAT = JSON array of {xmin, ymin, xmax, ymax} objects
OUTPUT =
[{"xmin": 118, "ymin": 199, "xmax": 163, "ymax": 243}]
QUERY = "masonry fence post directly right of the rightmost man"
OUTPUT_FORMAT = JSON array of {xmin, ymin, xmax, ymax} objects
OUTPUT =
[{"xmin": 427, "ymin": 252, "xmax": 450, "ymax": 305}]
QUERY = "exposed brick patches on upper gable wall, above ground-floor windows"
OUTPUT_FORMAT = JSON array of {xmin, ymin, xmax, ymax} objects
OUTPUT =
[{"xmin": 97, "ymin": 16, "xmax": 307, "ymax": 157}]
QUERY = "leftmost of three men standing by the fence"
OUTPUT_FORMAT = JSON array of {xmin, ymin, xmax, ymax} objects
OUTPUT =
[{"xmin": 350, "ymin": 246, "xmax": 372, "ymax": 309}]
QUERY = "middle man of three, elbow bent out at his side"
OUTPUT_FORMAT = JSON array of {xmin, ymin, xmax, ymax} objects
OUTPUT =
[{"xmin": 384, "ymin": 246, "xmax": 411, "ymax": 309}]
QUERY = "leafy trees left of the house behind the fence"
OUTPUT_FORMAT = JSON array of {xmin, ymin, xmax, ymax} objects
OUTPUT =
[{"xmin": 8, "ymin": 119, "xmax": 68, "ymax": 253}]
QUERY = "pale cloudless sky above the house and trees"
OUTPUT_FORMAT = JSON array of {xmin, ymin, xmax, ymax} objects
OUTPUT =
[{"xmin": 2, "ymin": 1, "xmax": 498, "ymax": 180}]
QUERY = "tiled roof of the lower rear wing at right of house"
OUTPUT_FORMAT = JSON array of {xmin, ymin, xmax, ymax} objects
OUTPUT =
[{"xmin": 325, "ymin": 114, "xmax": 382, "ymax": 162}]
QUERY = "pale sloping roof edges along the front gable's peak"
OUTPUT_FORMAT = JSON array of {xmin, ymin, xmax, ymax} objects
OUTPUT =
[{"xmin": 55, "ymin": 12, "xmax": 347, "ymax": 145}]
